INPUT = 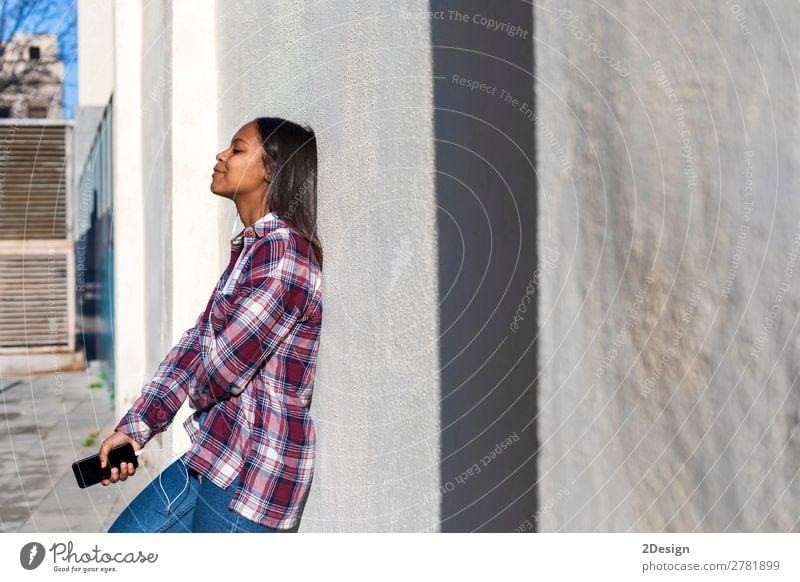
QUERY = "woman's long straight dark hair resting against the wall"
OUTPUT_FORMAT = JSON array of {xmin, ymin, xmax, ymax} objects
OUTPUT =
[{"xmin": 253, "ymin": 117, "xmax": 322, "ymax": 269}]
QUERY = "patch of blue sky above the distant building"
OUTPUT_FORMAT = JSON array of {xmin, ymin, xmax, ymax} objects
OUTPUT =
[{"xmin": 2, "ymin": 0, "xmax": 78, "ymax": 119}]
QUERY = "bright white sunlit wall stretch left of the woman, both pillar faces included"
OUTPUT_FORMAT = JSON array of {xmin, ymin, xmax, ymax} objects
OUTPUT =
[{"xmin": 114, "ymin": 0, "xmax": 225, "ymax": 465}]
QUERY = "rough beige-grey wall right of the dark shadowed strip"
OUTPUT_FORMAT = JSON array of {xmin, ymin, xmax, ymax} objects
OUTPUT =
[{"xmin": 534, "ymin": 0, "xmax": 800, "ymax": 532}]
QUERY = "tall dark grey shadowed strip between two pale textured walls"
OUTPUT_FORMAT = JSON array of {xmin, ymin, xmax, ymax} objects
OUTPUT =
[{"xmin": 430, "ymin": 0, "xmax": 538, "ymax": 532}]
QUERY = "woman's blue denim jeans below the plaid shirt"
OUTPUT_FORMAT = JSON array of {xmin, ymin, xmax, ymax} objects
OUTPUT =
[{"xmin": 108, "ymin": 412, "xmax": 278, "ymax": 533}]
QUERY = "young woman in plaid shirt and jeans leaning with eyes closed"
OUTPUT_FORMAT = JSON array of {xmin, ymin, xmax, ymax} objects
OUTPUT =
[{"xmin": 100, "ymin": 117, "xmax": 322, "ymax": 532}]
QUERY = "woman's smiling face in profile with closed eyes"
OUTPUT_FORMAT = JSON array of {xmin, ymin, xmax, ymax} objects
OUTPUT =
[{"xmin": 211, "ymin": 121, "xmax": 270, "ymax": 202}]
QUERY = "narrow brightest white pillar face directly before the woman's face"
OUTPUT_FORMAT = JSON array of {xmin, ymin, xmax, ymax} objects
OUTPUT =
[{"xmin": 167, "ymin": 0, "xmax": 225, "ymax": 452}]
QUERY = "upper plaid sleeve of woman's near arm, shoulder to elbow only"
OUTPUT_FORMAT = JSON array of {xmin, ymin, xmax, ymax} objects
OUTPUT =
[{"xmin": 189, "ymin": 231, "xmax": 311, "ymax": 410}]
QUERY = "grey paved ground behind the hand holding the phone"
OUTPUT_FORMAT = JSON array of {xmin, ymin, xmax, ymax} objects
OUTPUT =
[{"xmin": 0, "ymin": 370, "xmax": 158, "ymax": 532}]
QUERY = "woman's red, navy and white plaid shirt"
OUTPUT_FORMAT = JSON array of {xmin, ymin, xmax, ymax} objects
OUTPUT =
[{"xmin": 116, "ymin": 212, "xmax": 322, "ymax": 529}]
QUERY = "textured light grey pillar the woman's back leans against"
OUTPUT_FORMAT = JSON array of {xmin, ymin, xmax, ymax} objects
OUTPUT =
[{"xmin": 217, "ymin": 0, "xmax": 440, "ymax": 531}]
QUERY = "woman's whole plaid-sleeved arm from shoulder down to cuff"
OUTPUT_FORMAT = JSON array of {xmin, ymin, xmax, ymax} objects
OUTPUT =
[{"xmin": 115, "ymin": 232, "xmax": 310, "ymax": 447}]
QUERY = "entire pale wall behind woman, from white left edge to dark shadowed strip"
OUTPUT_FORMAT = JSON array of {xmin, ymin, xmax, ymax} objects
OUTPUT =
[{"xmin": 108, "ymin": 0, "xmax": 440, "ymax": 531}]
